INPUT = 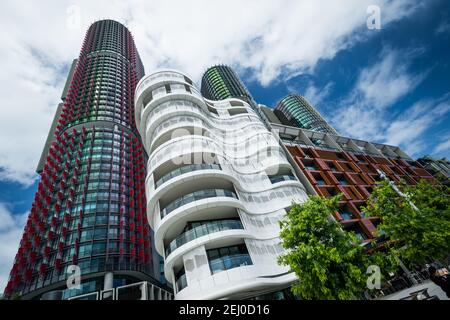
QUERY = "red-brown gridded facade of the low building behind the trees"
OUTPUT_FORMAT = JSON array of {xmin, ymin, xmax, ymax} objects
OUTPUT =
[{"xmin": 286, "ymin": 145, "xmax": 433, "ymax": 240}]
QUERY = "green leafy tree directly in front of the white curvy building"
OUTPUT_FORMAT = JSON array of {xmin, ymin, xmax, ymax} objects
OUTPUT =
[{"xmin": 279, "ymin": 195, "xmax": 386, "ymax": 300}]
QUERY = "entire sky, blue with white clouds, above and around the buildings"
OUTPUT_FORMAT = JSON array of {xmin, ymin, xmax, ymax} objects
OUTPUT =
[{"xmin": 0, "ymin": 0, "xmax": 450, "ymax": 291}]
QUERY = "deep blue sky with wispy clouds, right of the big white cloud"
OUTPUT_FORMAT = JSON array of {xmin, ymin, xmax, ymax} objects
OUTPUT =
[{"xmin": 243, "ymin": 1, "xmax": 450, "ymax": 158}]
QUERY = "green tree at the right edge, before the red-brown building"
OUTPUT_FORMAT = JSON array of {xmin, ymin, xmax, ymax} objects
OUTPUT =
[{"xmin": 363, "ymin": 179, "xmax": 450, "ymax": 265}]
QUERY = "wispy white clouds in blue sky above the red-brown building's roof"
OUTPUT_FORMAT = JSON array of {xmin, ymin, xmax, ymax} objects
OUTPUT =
[{"xmin": 332, "ymin": 47, "xmax": 450, "ymax": 156}]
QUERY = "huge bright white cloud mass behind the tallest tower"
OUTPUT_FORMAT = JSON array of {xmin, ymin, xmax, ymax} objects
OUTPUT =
[{"xmin": 0, "ymin": 0, "xmax": 418, "ymax": 184}]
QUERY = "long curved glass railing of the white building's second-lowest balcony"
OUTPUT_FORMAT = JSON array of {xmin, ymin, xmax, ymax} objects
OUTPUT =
[{"xmin": 166, "ymin": 220, "xmax": 244, "ymax": 257}]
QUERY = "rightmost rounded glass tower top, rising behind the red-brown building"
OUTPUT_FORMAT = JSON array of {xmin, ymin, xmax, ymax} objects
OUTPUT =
[{"xmin": 274, "ymin": 94, "xmax": 337, "ymax": 134}]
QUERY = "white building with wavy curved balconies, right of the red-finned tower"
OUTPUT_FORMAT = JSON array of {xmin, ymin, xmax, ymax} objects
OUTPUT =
[{"xmin": 135, "ymin": 70, "xmax": 307, "ymax": 299}]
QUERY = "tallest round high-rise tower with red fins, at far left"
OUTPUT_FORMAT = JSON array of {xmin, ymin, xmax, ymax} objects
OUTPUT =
[{"xmin": 5, "ymin": 20, "xmax": 165, "ymax": 299}]
